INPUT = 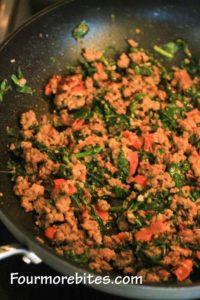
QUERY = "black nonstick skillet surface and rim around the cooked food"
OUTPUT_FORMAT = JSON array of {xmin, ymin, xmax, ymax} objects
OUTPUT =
[{"xmin": 0, "ymin": 0, "xmax": 200, "ymax": 299}]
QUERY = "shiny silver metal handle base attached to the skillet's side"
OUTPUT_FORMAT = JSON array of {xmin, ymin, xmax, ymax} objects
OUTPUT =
[{"xmin": 0, "ymin": 244, "xmax": 42, "ymax": 264}]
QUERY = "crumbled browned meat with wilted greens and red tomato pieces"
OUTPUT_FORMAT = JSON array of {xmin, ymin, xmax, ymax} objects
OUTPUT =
[{"xmin": 9, "ymin": 40, "xmax": 200, "ymax": 282}]
